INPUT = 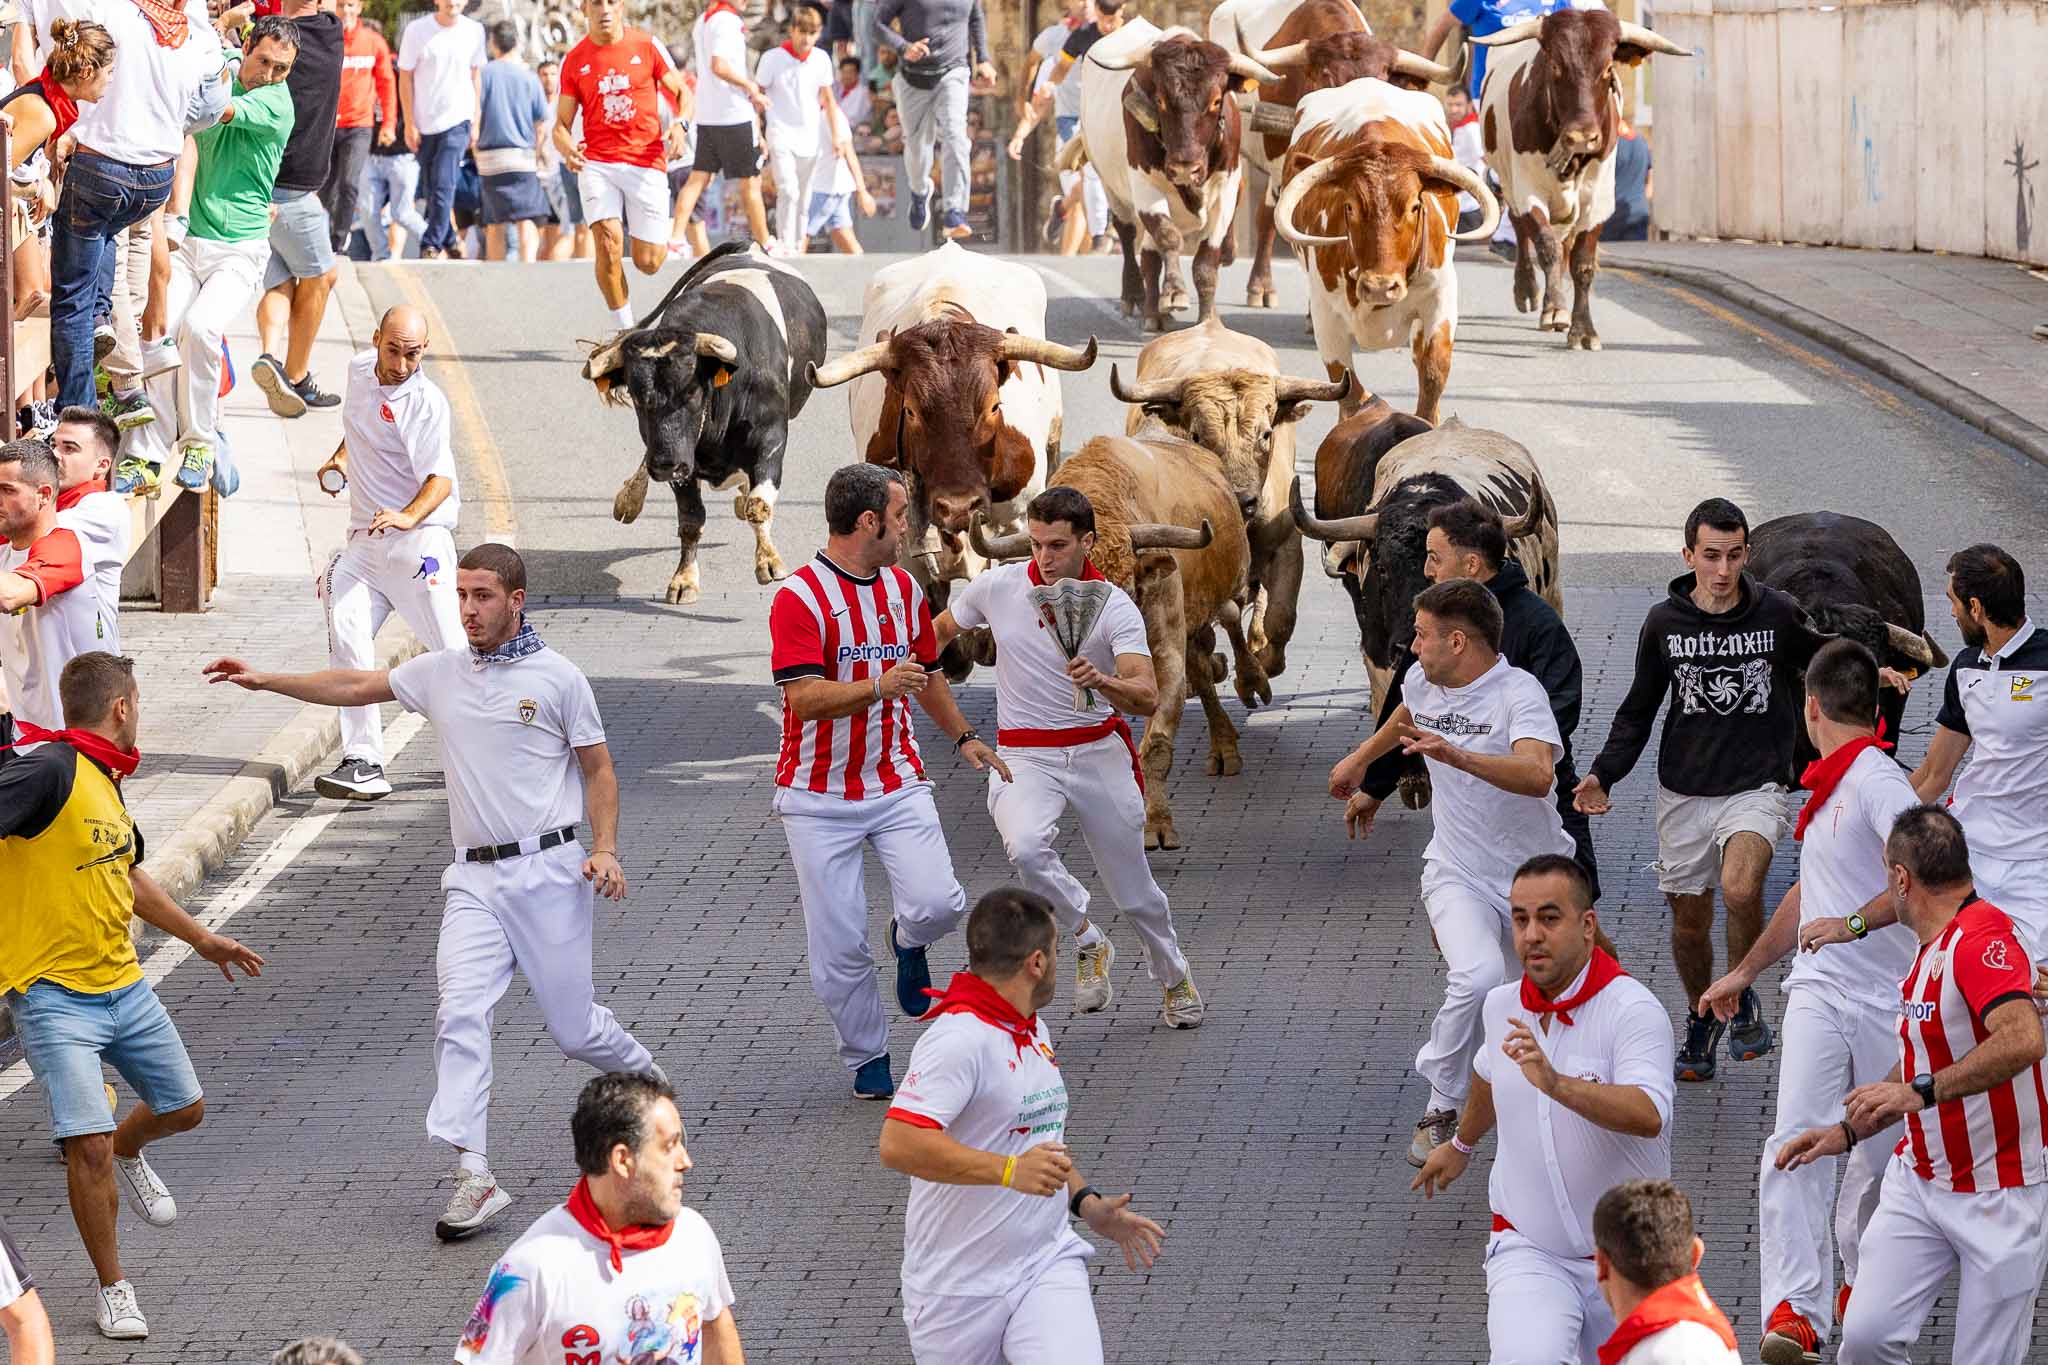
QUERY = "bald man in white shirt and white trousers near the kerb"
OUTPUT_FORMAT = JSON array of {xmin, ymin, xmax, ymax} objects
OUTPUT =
[{"xmin": 313, "ymin": 307, "xmax": 463, "ymax": 800}]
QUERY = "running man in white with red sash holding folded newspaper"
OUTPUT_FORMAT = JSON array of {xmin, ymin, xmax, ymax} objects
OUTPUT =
[{"xmin": 932, "ymin": 487, "xmax": 1202, "ymax": 1029}]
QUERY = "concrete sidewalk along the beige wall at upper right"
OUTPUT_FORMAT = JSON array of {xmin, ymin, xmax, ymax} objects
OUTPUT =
[{"xmin": 1599, "ymin": 241, "xmax": 2048, "ymax": 474}]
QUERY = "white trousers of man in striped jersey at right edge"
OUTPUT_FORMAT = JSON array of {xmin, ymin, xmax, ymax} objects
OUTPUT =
[{"xmin": 1835, "ymin": 1158, "xmax": 2048, "ymax": 1365}]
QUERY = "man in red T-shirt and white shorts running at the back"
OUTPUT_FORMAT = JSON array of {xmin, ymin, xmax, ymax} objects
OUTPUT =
[{"xmin": 555, "ymin": 0, "xmax": 686, "ymax": 327}]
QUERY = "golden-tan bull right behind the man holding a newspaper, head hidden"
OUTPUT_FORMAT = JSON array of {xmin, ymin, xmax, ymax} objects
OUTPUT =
[{"xmin": 975, "ymin": 424, "xmax": 1257, "ymax": 849}]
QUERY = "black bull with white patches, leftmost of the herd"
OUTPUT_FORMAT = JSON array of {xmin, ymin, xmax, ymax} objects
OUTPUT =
[{"xmin": 584, "ymin": 241, "xmax": 825, "ymax": 604}]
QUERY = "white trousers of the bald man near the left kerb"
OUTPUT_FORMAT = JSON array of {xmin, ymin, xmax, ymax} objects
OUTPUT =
[{"xmin": 322, "ymin": 526, "xmax": 465, "ymax": 767}]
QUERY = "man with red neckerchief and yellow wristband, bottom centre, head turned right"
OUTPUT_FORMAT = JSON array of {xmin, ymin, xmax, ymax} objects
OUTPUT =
[{"xmin": 881, "ymin": 886, "xmax": 1165, "ymax": 1365}]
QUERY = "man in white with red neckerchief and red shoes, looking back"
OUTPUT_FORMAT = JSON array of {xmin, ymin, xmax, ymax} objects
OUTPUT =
[{"xmin": 1698, "ymin": 641, "xmax": 1919, "ymax": 1365}]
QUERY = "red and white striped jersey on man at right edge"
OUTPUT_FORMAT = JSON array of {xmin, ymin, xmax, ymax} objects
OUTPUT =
[{"xmin": 1896, "ymin": 900, "xmax": 2048, "ymax": 1195}]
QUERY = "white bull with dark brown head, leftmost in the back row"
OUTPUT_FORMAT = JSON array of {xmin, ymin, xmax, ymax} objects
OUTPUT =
[{"xmin": 1061, "ymin": 18, "xmax": 1278, "ymax": 332}]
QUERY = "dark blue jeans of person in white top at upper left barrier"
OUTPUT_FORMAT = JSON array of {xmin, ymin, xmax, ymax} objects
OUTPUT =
[{"xmin": 49, "ymin": 149, "xmax": 178, "ymax": 407}]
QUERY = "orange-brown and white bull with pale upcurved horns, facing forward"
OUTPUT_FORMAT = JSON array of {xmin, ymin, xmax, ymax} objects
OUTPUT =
[{"xmin": 1274, "ymin": 80, "xmax": 1501, "ymax": 422}]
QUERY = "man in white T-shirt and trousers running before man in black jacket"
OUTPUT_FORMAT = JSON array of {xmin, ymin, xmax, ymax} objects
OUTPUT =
[{"xmin": 1329, "ymin": 579, "xmax": 1573, "ymax": 1166}]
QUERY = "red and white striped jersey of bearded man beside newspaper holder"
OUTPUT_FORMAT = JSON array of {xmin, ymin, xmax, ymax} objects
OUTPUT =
[{"xmin": 768, "ymin": 553, "xmax": 938, "ymax": 800}]
